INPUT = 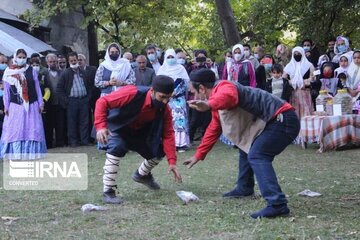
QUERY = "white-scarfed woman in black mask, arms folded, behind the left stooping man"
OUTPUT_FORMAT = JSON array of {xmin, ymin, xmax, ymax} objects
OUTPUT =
[{"xmin": 95, "ymin": 43, "xmax": 136, "ymax": 96}]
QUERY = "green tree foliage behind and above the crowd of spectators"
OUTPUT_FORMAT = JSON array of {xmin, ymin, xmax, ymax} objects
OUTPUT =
[{"xmin": 25, "ymin": 0, "xmax": 360, "ymax": 56}]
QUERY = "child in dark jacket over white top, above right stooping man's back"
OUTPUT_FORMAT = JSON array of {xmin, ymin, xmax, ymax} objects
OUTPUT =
[{"xmin": 265, "ymin": 64, "xmax": 294, "ymax": 102}]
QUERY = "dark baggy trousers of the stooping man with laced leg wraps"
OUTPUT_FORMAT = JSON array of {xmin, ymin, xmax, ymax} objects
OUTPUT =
[{"xmin": 106, "ymin": 128, "xmax": 165, "ymax": 160}]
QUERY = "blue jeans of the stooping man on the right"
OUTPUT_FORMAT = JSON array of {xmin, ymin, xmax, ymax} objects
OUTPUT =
[{"xmin": 236, "ymin": 110, "xmax": 300, "ymax": 205}]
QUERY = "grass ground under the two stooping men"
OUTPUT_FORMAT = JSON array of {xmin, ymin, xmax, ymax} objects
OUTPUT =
[{"xmin": 0, "ymin": 144, "xmax": 360, "ymax": 240}]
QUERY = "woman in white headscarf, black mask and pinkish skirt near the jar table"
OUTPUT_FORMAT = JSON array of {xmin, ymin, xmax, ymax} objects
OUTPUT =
[{"xmin": 283, "ymin": 47, "xmax": 315, "ymax": 119}]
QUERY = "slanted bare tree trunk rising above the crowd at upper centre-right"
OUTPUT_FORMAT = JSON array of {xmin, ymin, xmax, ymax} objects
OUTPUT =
[{"xmin": 215, "ymin": 0, "xmax": 240, "ymax": 47}]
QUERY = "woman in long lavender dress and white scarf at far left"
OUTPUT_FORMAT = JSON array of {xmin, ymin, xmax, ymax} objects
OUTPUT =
[{"xmin": 0, "ymin": 49, "xmax": 47, "ymax": 160}]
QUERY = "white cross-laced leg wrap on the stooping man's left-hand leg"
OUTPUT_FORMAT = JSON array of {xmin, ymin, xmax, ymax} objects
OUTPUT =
[{"xmin": 103, "ymin": 153, "xmax": 120, "ymax": 192}]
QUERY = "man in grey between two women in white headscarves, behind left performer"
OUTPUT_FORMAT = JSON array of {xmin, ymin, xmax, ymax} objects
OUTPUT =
[{"xmin": 134, "ymin": 55, "xmax": 155, "ymax": 86}]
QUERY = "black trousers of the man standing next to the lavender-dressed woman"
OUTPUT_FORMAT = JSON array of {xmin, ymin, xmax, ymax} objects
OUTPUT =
[{"xmin": 45, "ymin": 105, "xmax": 66, "ymax": 148}]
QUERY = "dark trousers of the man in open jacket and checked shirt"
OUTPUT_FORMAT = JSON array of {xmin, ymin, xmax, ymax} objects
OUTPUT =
[{"xmin": 67, "ymin": 97, "xmax": 89, "ymax": 146}]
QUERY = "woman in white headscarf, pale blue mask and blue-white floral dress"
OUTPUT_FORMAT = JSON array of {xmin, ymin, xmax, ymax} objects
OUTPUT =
[{"xmin": 157, "ymin": 49, "xmax": 190, "ymax": 152}]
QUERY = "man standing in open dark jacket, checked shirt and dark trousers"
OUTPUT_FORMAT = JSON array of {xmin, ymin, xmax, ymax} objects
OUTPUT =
[{"xmin": 57, "ymin": 52, "xmax": 93, "ymax": 147}]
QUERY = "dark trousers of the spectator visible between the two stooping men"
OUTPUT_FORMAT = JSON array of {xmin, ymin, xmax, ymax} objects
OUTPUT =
[{"xmin": 189, "ymin": 109, "xmax": 211, "ymax": 142}]
